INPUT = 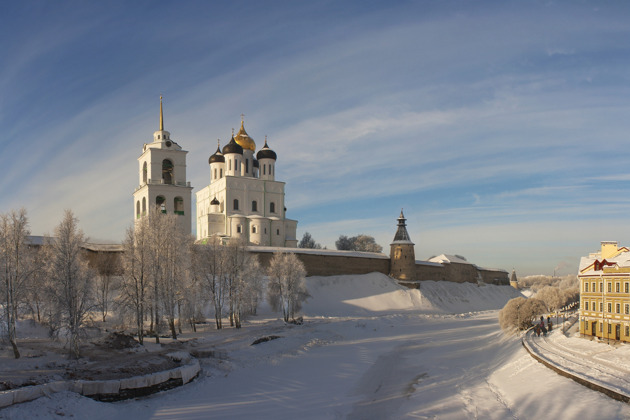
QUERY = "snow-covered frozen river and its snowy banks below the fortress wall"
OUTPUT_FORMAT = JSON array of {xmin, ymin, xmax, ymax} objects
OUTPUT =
[{"xmin": 0, "ymin": 274, "xmax": 630, "ymax": 420}]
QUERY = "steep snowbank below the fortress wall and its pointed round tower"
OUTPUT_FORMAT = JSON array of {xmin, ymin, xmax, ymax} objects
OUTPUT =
[{"xmin": 302, "ymin": 273, "xmax": 520, "ymax": 317}]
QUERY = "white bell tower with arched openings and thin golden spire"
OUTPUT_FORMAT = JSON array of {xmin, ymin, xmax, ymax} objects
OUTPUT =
[{"xmin": 133, "ymin": 96, "xmax": 192, "ymax": 234}]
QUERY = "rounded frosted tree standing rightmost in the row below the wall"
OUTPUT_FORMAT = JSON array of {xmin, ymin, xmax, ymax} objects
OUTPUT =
[{"xmin": 267, "ymin": 252, "xmax": 309, "ymax": 322}]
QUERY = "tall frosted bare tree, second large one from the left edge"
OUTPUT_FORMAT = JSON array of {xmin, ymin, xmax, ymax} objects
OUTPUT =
[{"xmin": 44, "ymin": 210, "xmax": 93, "ymax": 358}]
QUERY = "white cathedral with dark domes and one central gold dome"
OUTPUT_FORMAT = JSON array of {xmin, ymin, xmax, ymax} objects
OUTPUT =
[{"xmin": 196, "ymin": 120, "xmax": 297, "ymax": 247}]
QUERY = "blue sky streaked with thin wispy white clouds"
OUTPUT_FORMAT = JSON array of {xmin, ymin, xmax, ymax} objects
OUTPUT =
[{"xmin": 0, "ymin": 0, "xmax": 630, "ymax": 275}]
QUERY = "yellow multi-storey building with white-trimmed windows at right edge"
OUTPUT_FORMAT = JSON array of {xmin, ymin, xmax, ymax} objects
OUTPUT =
[{"xmin": 578, "ymin": 242, "xmax": 630, "ymax": 342}]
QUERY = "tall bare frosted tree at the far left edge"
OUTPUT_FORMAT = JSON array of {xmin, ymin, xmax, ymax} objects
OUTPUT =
[{"xmin": 0, "ymin": 208, "xmax": 30, "ymax": 359}]
